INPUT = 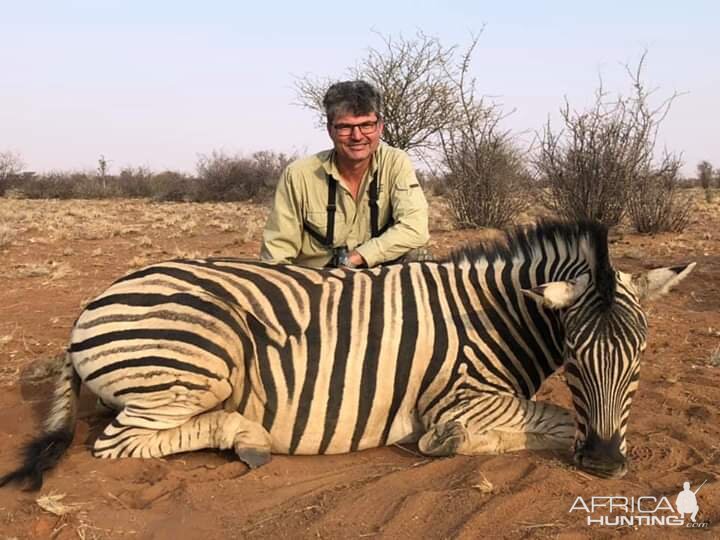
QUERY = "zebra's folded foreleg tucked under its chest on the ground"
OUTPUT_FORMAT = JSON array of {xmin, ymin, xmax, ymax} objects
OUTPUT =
[{"xmin": 418, "ymin": 396, "xmax": 575, "ymax": 456}]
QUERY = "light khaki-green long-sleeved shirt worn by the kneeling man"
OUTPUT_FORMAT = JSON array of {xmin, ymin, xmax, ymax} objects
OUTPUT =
[{"xmin": 260, "ymin": 143, "xmax": 429, "ymax": 267}]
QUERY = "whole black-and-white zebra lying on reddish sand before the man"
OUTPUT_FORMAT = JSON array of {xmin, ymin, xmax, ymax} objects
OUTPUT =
[{"xmin": 0, "ymin": 222, "xmax": 695, "ymax": 489}]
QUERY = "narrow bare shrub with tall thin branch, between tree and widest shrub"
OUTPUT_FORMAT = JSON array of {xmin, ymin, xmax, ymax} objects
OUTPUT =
[{"xmin": 440, "ymin": 38, "xmax": 529, "ymax": 228}]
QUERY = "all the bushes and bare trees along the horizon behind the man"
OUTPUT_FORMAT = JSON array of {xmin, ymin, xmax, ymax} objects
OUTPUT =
[{"xmin": 0, "ymin": 33, "xmax": 720, "ymax": 234}]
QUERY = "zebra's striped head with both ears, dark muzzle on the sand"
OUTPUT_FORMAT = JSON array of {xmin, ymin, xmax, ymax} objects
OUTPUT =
[{"xmin": 525, "ymin": 257, "xmax": 695, "ymax": 478}]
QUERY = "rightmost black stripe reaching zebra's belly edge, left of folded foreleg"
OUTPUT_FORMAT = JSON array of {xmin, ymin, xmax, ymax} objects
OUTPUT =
[{"xmin": 381, "ymin": 265, "xmax": 420, "ymax": 443}]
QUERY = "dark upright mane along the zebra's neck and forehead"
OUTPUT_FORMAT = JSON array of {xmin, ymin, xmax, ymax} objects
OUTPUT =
[{"xmin": 445, "ymin": 220, "xmax": 617, "ymax": 307}]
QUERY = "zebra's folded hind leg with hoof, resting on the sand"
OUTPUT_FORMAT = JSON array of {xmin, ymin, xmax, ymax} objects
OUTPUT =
[{"xmin": 93, "ymin": 405, "xmax": 272, "ymax": 468}]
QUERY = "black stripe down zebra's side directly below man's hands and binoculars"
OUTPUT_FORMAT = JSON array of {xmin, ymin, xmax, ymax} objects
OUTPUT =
[{"xmin": 318, "ymin": 273, "xmax": 356, "ymax": 454}]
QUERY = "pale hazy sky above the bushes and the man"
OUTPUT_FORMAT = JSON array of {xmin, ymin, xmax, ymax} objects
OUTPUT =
[{"xmin": 0, "ymin": 0, "xmax": 720, "ymax": 175}]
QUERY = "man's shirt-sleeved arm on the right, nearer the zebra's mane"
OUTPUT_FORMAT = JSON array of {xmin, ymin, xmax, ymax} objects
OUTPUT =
[{"xmin": 356, "ymin": 154, "xmax": 430, "ymax": 266}]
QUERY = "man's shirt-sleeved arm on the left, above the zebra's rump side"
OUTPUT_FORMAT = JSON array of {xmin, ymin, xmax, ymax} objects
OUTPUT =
[{"xmin": 260, "ymin": 168, "xmax": 303, "ymax": 263}]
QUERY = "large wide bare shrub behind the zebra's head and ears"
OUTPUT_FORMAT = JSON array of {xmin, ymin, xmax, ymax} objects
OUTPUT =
[{"xmin": 534, "ymin": 51, "xmax": 677, "ymax": 226}]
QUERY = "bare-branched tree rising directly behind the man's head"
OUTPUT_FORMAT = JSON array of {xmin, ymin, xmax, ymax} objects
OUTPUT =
[{"xmin": 295, "ymin": 32, "xmax": 466, "ymax": 159}]
